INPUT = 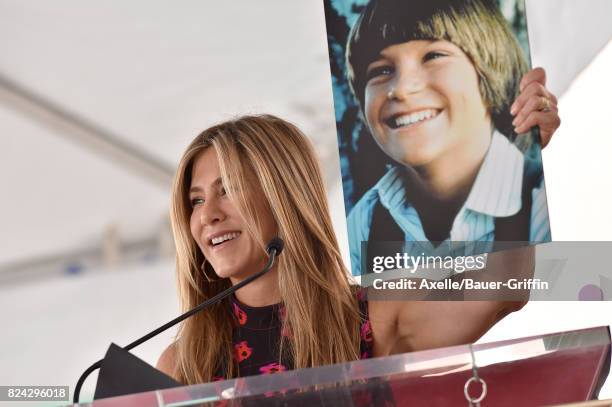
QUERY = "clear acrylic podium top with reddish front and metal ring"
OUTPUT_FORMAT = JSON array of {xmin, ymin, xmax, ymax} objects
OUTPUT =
[{"xmin": 82, "ymin": 327, "xmax": 610, "ymax": 407}]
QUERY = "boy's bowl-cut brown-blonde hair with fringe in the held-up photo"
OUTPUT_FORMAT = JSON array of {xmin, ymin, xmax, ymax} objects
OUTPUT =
[{"xmin": 346, "ymin": 0, "xmax": 527, "ymax": 141}]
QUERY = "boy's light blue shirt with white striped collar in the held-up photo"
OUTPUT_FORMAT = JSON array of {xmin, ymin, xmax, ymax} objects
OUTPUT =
[{"xmin": 347, "ymin": 131, "xmax": 551, "ymax": 275}]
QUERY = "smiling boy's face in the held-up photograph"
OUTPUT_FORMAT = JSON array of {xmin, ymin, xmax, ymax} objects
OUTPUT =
[{"xmin": 364, "ymin": 40, "xmax": 491, "ymax": 166}]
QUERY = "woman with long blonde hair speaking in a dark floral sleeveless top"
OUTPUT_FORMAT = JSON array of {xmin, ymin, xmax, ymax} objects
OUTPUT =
[{"xmin": 158, "ymin": 115, "xmax": 556, "ymax": 384}]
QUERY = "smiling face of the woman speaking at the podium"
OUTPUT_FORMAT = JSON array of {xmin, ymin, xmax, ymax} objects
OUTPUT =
[{"xmin": 189, "ymin": 147, "xmax": 276, "ymax": 284}]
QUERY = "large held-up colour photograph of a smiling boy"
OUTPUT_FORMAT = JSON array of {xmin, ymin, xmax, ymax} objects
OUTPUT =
[{"xmin": 326, "ymin": 0, "xmax": 550, "ymax": 275}]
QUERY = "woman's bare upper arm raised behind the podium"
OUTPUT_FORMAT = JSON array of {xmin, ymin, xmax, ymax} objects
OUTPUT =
[{"xmin": 369, "ymin": 247, "xmax": 535, "ymax": 356}]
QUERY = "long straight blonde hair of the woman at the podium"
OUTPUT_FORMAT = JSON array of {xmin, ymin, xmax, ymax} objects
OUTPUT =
[{"xmin": 171, "ymin": 115, "xmax": 360, "ymax": 384}]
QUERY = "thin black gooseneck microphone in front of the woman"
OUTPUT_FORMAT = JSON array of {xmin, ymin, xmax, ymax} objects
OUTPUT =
[{"xmin": 73, "ymin": 237, "xmax": 285, "ymax": 404}]
